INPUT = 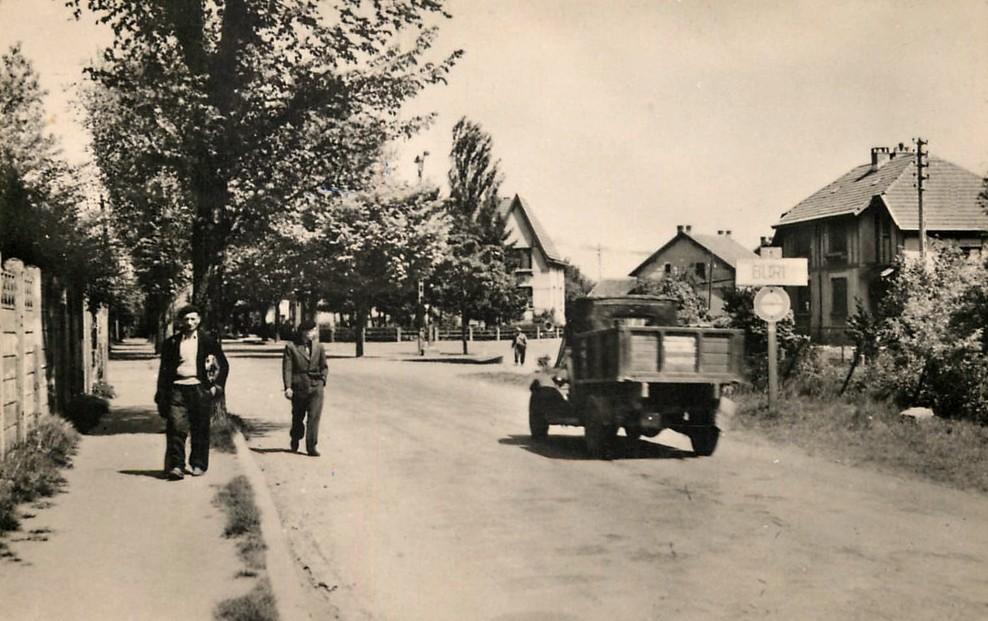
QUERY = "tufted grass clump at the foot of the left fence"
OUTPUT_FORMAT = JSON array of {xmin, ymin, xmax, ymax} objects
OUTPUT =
[{"xmin": 0, "ymin": 415, "xmax": 79, "ymax": 534}]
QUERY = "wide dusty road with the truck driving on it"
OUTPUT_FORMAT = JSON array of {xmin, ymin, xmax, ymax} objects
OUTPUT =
[{"xmin": 229, "ymin": 348, "xmax": 988, "ymax": 621}]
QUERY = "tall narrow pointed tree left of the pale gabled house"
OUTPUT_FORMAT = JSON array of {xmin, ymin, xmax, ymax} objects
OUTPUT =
[{"xmin": 429, "ymin": 118, "xmax": 526, "ymax": 354}]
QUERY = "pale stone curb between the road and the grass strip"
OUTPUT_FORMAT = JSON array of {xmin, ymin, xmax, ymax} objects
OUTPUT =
[{"xmin": 233, "ymin": 427, "xmax": 312, "ymax": 621}]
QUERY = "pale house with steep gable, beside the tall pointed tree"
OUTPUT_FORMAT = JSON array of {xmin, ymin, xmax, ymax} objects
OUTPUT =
[{"xmin": 499, "ymin": 194, "xmax": 566, "ymax": 325}]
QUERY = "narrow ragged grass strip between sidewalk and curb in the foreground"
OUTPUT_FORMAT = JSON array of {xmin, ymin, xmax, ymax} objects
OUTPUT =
[{"xmin": 213, "ymin": 476, "xmax": 278, "ymax": 621}]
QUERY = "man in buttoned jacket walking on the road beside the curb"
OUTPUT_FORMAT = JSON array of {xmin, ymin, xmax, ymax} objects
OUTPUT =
[{"xmin": 281, "ymin": 319, "xmax": 328, "ymax": 457}]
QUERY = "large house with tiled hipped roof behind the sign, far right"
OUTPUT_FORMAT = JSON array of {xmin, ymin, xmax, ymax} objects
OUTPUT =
[{"xmin": 773, "ymin": 143, "xmax": 988, "ymax": 342}]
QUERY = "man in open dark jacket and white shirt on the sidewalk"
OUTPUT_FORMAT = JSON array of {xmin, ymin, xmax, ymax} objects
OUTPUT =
[{"xmin": 154, "ymin": 305, "xmax": 230, "ymax": 480}]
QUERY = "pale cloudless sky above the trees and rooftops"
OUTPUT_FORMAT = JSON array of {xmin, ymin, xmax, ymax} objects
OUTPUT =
[{"xmin": 0, "ymin": 0, "xmax": 988, "ymax": 278}]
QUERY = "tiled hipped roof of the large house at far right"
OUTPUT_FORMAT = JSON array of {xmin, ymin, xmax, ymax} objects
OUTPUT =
[{"xmin": 773, "ymin": 153, "xmax": 988, "ymax": 231}]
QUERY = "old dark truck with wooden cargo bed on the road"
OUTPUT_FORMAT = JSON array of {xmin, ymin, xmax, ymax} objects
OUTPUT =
[{"xmin": 528, "ymin": 295, "xmax": 744, "ymax": 458}]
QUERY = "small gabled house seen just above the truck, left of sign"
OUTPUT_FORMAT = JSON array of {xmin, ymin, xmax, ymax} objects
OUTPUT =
[{"xmin": 630, "ymin": 224, "xmax": 757, "ymax": 316}]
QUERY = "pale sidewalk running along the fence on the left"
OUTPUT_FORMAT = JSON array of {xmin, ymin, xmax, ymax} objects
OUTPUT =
[{"xmin": 0, "ymin": 347, "xmax": 247, "ymax": 621}]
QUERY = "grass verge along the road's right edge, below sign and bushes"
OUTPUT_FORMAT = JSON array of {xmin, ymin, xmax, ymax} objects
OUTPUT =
[{"xmin": 734, "ymin": 393, "xmax": 988, "ymax": 493}]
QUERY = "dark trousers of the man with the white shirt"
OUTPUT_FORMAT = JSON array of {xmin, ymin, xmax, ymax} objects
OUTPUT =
[{"xmin": 165, "ymin": 384, "xmax": 213, "ymax": 470}]
